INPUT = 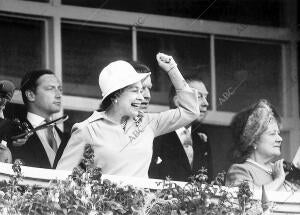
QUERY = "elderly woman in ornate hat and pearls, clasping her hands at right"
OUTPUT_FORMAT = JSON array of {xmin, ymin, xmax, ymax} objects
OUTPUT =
[{"xmin": 226, "ymin": 100, "xmax": 294, "ymax": 191}]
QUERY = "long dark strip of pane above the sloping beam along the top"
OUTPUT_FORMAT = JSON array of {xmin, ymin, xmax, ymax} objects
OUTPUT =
[{"xmin": 62, "ymin": 0, "xmax": 286, "ymax": 26}]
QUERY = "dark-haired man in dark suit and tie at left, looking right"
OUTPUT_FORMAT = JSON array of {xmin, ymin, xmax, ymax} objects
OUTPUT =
[{"xmin": 11, "ymin": 69, "xmax": 67, "ymax": 169}]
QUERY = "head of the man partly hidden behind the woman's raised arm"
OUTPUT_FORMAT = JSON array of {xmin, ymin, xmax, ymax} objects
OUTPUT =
[{"xmin": 169, "ymin": 76, "xmax": 209, "ymax": 122}]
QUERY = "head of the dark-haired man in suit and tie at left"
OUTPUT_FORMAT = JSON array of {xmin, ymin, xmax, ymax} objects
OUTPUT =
[{"xmin": 21, "ymin": 69, "xmax": 62, "ymax": 118}]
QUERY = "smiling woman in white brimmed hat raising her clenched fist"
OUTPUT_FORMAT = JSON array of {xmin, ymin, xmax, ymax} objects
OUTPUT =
[{"xmin": 57, "ymin": 53, "xmax": 199, "ymax": 178}]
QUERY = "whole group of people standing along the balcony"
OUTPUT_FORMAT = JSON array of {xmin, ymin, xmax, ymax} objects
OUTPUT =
[{"xmin": 0, "ymin": 53, "xmax": 299, "ymax": 191}]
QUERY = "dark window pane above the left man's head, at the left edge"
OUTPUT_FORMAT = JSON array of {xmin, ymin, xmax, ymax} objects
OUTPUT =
[{"xmin": 0, "ymin": 16, "xmax": 44, "ymax": 80}]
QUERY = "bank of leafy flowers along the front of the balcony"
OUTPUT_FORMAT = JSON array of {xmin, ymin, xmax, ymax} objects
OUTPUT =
[{"xmin": 0, "ymin": 145, "xmax": 272, "ymax": 215}]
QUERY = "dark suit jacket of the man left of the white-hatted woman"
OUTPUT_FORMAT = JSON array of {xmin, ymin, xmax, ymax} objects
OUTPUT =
[{"xmin": 10, "ymin": 120, "xmax": 68, "ymax": 169}]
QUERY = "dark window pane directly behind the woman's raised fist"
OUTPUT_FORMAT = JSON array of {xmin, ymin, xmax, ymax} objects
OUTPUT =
[{"xmin": 138, "ymin": 32, "xmax": 210, "ymax": 105}]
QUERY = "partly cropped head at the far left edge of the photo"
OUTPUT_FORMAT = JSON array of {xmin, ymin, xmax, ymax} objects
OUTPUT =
[{"xmin": 0, "ymin": 80, "xmax": 15, "ymax": 111}]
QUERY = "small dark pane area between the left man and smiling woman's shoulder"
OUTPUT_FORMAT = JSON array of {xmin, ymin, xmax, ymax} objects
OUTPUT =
[{"xmin": 64, "ymin": 110, "xmax": 92, "ymax": 133}]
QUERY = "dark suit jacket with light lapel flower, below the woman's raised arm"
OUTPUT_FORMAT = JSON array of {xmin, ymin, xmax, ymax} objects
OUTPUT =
[{"xmin": 148, "ymin": 124, "xmax": 212, "ymax": 181}]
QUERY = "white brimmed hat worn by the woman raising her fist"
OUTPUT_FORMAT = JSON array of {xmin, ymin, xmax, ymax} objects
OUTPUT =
[{"xmin": 99, "ymin": 60, "xmax": 150, "ymax": 101}]
